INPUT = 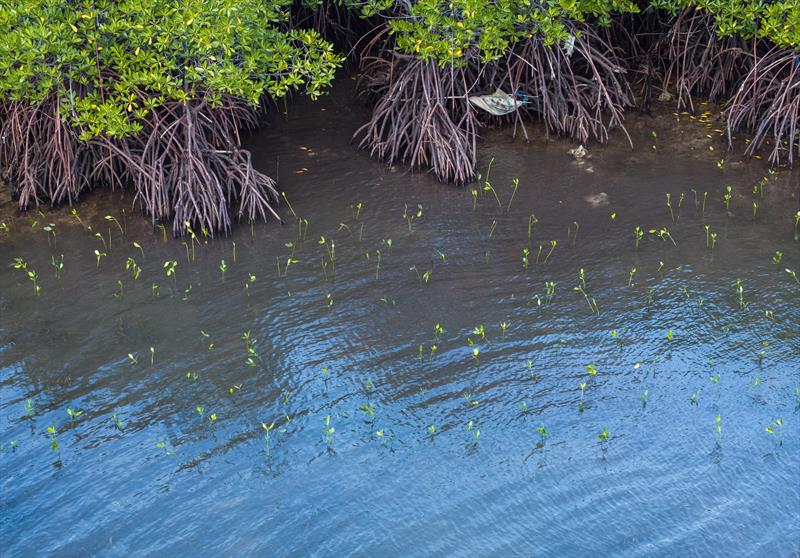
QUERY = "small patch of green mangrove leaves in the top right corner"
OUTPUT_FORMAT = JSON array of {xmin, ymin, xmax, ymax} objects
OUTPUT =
[{"xmin": 651, "ymin": 0, "xmax": 800, "ymax": 48}]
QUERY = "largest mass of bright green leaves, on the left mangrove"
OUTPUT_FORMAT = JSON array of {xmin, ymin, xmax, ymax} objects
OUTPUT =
[{"xmin": 0, "ymin": 0, "xmax": 341, "ymax": 140}]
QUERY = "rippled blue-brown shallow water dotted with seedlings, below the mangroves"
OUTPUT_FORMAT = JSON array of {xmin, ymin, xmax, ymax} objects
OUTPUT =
[{"xmin": 0, "ymin": 88, "xmax": 800, "ymax": 556}]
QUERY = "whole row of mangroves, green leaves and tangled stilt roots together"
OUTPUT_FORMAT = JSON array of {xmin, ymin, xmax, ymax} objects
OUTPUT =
[{"xmin": 0, "ymin": 0, "xmax": 800, "ymax": 234}]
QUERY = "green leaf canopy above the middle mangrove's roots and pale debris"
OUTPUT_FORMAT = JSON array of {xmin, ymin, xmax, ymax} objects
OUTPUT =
[{"xmin": 389, "ymin": 0, "xmax": 638, "ymax": 65}]
